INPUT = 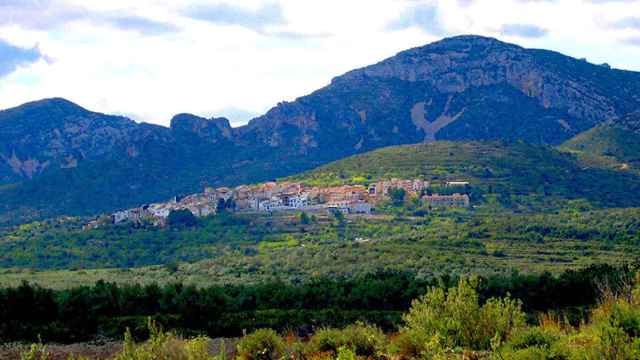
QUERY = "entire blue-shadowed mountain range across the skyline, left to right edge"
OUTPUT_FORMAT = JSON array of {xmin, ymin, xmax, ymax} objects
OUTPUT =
[{"xmin": 0, "ymin": 36, "xmax": 640, "ymax": 223}]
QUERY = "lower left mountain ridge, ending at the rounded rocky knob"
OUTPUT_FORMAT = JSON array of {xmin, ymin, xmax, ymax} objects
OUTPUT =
[{"xmin": 0, "ymin": 99, "xmax": 242, "ymax": 223}]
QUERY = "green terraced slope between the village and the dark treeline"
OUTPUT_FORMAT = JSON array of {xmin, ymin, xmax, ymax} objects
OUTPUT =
[{"xmin": 0, "ymin": 205, "xmax": 640, "ymax": 288}]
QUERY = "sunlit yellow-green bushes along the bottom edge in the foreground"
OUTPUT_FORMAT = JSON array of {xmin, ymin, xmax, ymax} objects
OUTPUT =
[{"xmin": 18, "ymin": 270, "xmax": 640, "ymax": 360}]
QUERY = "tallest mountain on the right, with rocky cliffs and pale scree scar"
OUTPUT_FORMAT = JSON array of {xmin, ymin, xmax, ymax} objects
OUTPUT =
[{"xmin": 240, "ymin": 36, "xmax": 640, "ymax": 155}]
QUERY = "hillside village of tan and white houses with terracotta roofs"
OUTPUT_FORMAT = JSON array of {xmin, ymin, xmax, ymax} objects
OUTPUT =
[{"xmin": 88, "ymin": 179, "xmax": 469, "ymax": 227}]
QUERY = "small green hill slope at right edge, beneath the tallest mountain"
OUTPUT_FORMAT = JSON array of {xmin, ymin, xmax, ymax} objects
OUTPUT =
[{"xmin": 561, "ymin": 124, "xmax": 640, "ymax": 174}]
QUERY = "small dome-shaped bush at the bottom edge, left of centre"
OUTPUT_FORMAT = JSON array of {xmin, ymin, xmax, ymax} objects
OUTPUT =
[{"xmin": 237, "ymin": 329, "xmax": 285, "ymax": 360}]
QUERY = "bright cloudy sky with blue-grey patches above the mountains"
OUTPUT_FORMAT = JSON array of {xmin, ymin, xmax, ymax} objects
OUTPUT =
[{"xmin": 0, "ymin": 0, "xmax": 640, "ymax": 126}]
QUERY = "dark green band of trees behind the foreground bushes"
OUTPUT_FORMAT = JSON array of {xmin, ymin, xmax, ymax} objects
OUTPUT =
[{"xmin": 0, "ymin": 265, "xmax": 632, "ymax": 342}]
